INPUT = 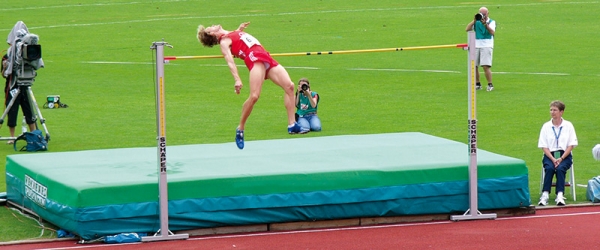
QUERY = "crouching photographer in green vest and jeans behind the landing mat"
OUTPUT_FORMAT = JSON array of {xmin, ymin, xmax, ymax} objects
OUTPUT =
[{"xmin": 296, "ymin": 78, "xmax": 321, "ymax": 133}]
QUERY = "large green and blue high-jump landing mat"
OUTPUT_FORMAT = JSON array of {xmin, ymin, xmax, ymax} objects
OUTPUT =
[{"xmin": 6, "ymin": 132, "xmax": 529, "ymax": 237}]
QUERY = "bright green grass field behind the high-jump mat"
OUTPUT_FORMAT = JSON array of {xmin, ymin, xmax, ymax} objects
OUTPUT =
[{"xmin": 0, "ymin": 0, "xmax": 600, "ymax": 241}]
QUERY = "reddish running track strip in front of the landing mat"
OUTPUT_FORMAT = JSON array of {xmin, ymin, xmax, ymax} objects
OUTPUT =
[{"xmin": 4, "ymin": 206, "xmax": 600, "ymax": 250}]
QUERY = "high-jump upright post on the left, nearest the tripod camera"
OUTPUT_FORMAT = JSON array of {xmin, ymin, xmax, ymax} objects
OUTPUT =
[{"xmin": 142, "ymin": 41, "xmax": 189, "ymax": 241}]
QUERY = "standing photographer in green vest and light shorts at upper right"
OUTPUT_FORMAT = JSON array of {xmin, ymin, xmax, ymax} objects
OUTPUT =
[{"xmin": 467, "ymin": 7, "xmax": 496, "ymax": 91}]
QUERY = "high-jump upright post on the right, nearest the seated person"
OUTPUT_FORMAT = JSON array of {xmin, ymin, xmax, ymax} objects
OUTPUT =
[{"xmin": 450, "ymin": 31, "xmax": 496, "ymax": 221}]
